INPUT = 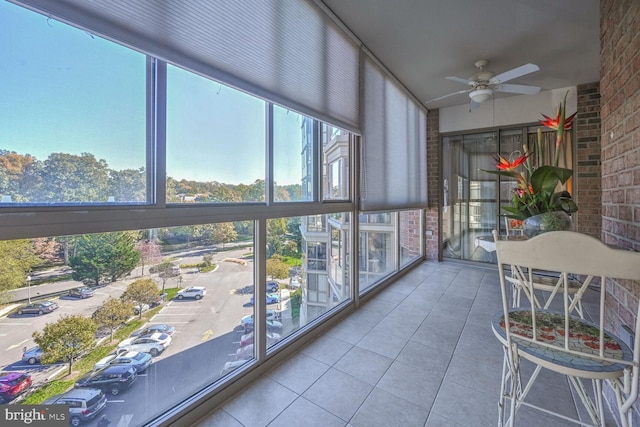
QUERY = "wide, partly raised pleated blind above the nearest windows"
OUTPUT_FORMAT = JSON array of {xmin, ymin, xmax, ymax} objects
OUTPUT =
[{"xmin": 15, "ymin": 0, "xmax": 360, "ymax": 133}]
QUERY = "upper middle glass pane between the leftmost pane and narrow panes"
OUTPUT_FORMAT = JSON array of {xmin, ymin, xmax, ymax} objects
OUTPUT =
[{"xmin": 167, "ymin": 65, "xmax": 266, "ymax": 203}]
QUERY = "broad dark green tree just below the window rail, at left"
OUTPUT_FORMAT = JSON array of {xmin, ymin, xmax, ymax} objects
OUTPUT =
[{"xmin": 69, "ymin": 232, "xmax": 140, "ymax": 286}]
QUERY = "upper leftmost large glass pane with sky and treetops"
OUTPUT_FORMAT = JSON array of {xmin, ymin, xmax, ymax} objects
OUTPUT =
[{"xmin": 0, "ymin": 2, "xmax": 149, "ymax": 207}]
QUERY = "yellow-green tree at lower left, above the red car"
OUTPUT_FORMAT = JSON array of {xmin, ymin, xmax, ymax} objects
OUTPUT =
[{"xmin": 32, "ymin": 314, "xmax": 97, "ymax": 374}]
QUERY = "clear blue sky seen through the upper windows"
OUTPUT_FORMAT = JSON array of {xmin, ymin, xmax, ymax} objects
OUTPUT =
[{"xmin": 0, "ymin": 1, "xmax": 302, "ymax": 185}]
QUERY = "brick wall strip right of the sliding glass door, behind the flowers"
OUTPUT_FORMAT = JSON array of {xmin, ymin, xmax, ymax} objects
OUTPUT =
[{"xmin": 574, "ymin": 82, "xmax": 602, "ymax": 239}]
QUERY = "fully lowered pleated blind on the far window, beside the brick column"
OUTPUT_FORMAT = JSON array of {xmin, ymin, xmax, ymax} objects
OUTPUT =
[{"xmin": 360, "ymin": 56, "xmax": 427, "ymax": 211}]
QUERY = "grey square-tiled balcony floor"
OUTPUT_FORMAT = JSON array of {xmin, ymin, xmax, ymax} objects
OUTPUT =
[{"xmin": 197, "ymin": 262, "xmax": 615, "ymax": 427}]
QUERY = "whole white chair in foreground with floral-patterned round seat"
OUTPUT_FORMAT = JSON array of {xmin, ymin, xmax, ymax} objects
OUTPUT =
[{"xmin": 492, "ymin": 231, "xmax": 640, "ymax": 427}]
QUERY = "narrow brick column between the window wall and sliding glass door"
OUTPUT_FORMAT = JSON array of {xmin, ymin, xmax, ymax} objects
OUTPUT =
[{"xmin": 425, "ymin": 110, "xmax": 440, "ymax": 260}]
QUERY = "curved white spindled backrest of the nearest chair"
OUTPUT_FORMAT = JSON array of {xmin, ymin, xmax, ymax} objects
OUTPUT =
[{"xmin": 493, "ymin": 230, "xmax": 640, "ymax": 372}]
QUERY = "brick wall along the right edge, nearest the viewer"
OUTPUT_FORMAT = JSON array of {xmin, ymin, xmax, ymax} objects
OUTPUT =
[{"xmin": 600, "ymin": 0, "xmax": 640, "ymax": 425}]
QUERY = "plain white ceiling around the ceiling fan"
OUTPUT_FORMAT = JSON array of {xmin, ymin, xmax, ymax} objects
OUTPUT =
[{"xmin": 322, "ymin": 0, "xmax": 600, "ymax": 108}]
